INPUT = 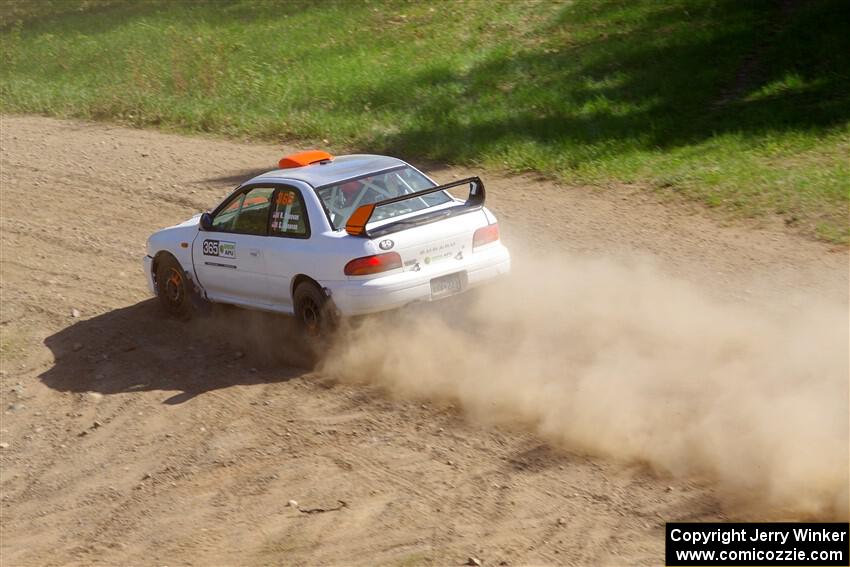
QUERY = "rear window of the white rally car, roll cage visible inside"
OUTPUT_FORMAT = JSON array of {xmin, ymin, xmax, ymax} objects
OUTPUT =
[{"xmin": 316, "ymin": 166, "xmax": 451, "ymax": 229}]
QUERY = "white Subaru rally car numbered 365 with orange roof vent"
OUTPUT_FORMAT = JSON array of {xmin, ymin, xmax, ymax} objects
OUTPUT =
[{"xmin": 144, "ymin": 150, "xmax": 510, "ymax": 334}]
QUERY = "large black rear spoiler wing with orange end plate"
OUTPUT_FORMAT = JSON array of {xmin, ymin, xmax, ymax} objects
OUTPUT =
[{"xmin": 345, "ymin": 177, "xmax": 484, "ymax": 238}]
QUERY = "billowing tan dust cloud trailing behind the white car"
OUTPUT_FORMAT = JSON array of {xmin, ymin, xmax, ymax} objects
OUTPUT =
[{"xmin": 321, "ymin": 244, "xmax": 850, "ymax": 518}]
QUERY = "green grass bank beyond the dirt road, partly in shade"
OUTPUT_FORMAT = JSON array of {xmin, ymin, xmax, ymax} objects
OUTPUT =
[{"xmin": 0, "ymin": 0, "xmax": 850, "ymax": 242}]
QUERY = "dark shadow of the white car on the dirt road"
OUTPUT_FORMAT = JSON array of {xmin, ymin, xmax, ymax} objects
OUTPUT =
[{"xmin": 40, "ymin": 299, "xmax": 316, "ymax": 404}]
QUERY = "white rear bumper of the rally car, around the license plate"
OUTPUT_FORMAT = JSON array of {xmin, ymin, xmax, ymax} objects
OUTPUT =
[{"xmin": 325, "ymin": 243, "xmax": 511, "ymax": 317}]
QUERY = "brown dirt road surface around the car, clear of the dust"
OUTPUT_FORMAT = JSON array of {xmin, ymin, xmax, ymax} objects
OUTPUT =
[{"xmin": 0, "ymin": 116, "xmax": 848, "ymax": 566}]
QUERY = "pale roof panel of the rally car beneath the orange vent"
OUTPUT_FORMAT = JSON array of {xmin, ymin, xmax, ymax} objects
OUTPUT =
[{"xmin": 246, "ymin": 154, "xmax": 407, "ymax": 187}]
